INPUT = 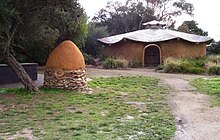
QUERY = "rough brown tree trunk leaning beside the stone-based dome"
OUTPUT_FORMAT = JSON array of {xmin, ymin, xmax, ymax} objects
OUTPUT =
[{"xmin": 0, "ymin": 53, "xmax": 40, "ymax": 93}]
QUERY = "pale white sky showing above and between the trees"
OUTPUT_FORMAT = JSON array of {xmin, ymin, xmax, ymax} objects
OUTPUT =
[{"xmin": 79, "ymin": 0, "xmax": 220, "ymax": 41}]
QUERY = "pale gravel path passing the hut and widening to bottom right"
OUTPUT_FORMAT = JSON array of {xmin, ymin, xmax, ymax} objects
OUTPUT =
[{"xmin": 0, "ymin": 68, "xmax": 220, "ymax": 140}]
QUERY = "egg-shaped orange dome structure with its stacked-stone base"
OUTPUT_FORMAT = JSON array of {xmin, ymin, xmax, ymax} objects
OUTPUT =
[{"xmin": 44, "ymin": 41, "xmax": 87, "ymax": 91}]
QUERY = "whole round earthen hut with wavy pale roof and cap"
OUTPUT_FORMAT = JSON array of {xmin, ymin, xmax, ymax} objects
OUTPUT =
[{"xmin": 98, "ymin": 21, "xmax": 212, "ymax": 67}]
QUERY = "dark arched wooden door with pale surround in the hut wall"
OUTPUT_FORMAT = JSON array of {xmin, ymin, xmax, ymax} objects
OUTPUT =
[{"xmin": 143, "ymin": 44, "xmax": 161, "ymax": 67}]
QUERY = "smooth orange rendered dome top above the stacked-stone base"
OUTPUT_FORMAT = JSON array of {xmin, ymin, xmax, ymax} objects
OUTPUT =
[{"xmin": 46, "ymin": 40, "xmax": 85, "ymax": 70}]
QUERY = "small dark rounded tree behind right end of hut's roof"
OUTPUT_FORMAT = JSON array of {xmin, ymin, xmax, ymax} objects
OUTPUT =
[{"xmin": 177, "ymin": 20, "xmax": 208, "ymax": 36}]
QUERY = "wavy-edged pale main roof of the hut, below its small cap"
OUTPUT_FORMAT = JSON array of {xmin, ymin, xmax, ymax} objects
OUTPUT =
[{"xmin": 98, "ymin": 29, "xmax": 212, "ymax": 45}]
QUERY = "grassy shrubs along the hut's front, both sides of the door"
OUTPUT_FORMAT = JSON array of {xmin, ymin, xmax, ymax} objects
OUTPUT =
[{"xmin": 102, "ymin": 55, "xmax": 220, "ymax": 75}]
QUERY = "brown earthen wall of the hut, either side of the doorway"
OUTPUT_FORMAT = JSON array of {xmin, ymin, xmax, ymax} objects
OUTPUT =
[{"xmin": 104, "ymin": 39, "xmax": 206, "ymax": 66}]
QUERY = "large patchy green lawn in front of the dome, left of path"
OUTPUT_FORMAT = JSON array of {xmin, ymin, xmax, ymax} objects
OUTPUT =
[{"xmin": 0, "ymin": 77, "xmax": 175, "ymax": 140}]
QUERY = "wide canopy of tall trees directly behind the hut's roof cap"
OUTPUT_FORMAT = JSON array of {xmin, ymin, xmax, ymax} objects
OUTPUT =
[{"xmin": 93, "ymin": 0, "xmax": 194, "ymax": 34}]
